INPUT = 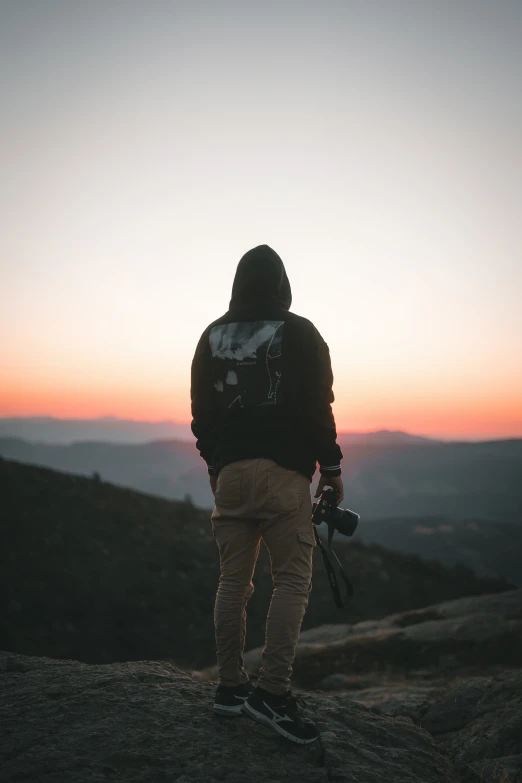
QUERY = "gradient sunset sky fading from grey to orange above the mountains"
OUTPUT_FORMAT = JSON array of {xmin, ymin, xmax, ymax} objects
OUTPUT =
[{"xmin": 0, "ymin": 0, "xmax": 522, "ymax": 439}]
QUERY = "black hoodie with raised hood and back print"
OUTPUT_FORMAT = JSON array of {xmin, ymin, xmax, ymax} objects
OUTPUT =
[{"xmin": 191, "ymin": 245, "xmax": 342, "ymax": 478}]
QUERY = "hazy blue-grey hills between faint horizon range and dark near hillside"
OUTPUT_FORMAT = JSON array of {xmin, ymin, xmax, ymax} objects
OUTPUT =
[{"xmin": 0, "ymin": 433, "xmax": 522, "ymax": 525}]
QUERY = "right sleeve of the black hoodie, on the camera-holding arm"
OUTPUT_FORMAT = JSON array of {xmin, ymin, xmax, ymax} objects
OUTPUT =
[{"xmin": 307, "ymin": 327, "xmax": 343, "ymax": 478}]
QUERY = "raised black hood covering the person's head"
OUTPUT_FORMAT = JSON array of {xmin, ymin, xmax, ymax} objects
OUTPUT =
[{"xmin": 230, "ymin": 245, "xmax": 292, "ymax": 310}]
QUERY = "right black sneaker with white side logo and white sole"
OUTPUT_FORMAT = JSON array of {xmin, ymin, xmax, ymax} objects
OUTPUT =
[{"xmin": 243, "ymin": 686, "xmax": 319, "ymax": 745}]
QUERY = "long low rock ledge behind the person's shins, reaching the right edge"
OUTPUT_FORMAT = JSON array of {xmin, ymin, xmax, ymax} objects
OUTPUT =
[{"xmin": 194, "ymin": 589, "xmax": 522, "ymax": 688}]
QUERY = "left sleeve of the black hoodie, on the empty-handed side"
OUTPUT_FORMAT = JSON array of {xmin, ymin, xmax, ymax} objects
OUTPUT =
[{"xmin": 190, "ymin": 331, "xmax": 217, "ymax": 476}]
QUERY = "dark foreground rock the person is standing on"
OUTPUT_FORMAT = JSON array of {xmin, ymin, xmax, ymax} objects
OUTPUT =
[{"xmin": 0, "ymin": 653, "xmax": 458, "ymax": 783}]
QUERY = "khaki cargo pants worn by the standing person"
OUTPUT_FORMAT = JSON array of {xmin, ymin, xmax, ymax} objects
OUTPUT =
[{"xmin": 212, "ymin": 459, "xmax": 315, "ymax": 694}]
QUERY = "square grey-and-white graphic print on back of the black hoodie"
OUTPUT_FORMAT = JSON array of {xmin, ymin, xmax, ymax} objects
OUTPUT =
[{"xmin": 209, "ymin": 321, "xmax": 284, "ymax": 410}]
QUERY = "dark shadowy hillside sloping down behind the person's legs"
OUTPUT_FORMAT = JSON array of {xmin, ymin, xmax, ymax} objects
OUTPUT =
[{"xmin": 0, "ymin": 459, "xmax": 507, "ymax": 667}]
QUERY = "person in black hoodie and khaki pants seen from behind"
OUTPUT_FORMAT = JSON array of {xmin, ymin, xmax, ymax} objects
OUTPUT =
[{"xmin": 191, "ymin": 245, "xmax": 344, "ymax": 744}]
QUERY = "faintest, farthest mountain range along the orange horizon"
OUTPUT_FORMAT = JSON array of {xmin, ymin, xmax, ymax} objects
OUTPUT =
[{"xmin": 0, "ymin": 416, "xmax": 437, "ymax": 445}]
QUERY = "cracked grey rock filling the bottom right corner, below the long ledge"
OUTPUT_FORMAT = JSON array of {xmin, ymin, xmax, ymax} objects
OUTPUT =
[{"xmin": 316, "ymin": 669, "xmax": 522, "ymax": 783}]
